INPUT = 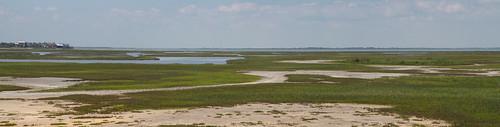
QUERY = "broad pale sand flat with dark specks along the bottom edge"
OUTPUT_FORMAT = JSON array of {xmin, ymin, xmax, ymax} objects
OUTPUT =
[{"xmin": 0, "ymin": 103, "xmax": 450, "ymax": 127}]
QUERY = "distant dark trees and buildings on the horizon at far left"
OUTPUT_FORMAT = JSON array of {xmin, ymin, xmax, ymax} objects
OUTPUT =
[{"xmin": 0, "ymin": 42, "xmax": 73, "ymax": 49}]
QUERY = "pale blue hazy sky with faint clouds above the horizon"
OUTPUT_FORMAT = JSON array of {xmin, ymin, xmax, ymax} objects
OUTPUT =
[{"xmin": 0, "ymin": 0, "xmax": 500, "ymax": 48}]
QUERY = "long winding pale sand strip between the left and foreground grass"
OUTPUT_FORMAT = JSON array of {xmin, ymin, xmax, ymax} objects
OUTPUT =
[{"xmin": 0, "ymin": 70, "xmax": 410, "ymax": 99}]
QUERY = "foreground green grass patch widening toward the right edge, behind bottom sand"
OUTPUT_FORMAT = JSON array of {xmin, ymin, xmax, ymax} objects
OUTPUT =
[{"xmin": 49, "ymin": 76, "xmax": 500, "ymax": 126}]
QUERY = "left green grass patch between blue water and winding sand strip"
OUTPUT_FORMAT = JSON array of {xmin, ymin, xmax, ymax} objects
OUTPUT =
[{"xmin": 0, "ymin": 63, "xmax": 258, "ymax": 91}]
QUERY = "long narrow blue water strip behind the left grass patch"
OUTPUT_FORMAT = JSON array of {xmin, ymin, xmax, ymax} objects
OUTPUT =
[{"xmin": 0, "ymin": 57, "xmax": 243, "ymax": 64}]
